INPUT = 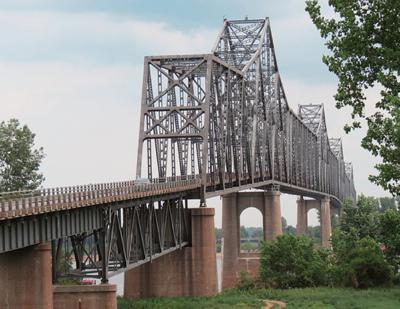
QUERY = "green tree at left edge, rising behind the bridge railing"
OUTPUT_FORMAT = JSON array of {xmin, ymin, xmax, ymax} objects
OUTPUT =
[{"xmin": 0, "ymin": 119, "xmax": 44, "ymax": 192}]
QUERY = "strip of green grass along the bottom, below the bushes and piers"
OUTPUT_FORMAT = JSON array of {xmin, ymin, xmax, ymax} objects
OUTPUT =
[{"xmin": 118, "ymin": 287, "xmax": 400, "ymax": 309}]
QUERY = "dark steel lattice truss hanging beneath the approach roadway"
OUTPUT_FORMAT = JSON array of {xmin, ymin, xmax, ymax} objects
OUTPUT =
[{"xmin": 52, "ymin": 198, "xmax": 191, "ymax": 282}]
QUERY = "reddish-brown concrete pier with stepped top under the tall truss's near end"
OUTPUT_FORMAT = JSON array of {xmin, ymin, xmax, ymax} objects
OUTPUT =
[{"xmin": 124, "ymin": 207, "xmax": 218, "ymax": 298}]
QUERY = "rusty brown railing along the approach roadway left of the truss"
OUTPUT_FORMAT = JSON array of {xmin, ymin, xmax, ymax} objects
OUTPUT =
[{"xmin": 0, "ymin": 176, "xmax": 200, "ymax": 220}]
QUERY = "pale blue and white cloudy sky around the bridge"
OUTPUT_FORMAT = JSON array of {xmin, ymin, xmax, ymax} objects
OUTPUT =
[{"xmin": 0, "ymin": 0, "xmax": 388, "ymax": 226}]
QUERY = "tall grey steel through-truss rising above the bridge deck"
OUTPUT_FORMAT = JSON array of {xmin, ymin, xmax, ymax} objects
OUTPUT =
[{"xmin": 137, "ymin": 18, "xmax": 355, "ymax": 200}]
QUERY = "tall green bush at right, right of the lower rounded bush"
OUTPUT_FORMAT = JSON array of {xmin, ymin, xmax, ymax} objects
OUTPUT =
[{"xmin": 331, "ymin": 196, "xmax": 393, "ymax": 288}]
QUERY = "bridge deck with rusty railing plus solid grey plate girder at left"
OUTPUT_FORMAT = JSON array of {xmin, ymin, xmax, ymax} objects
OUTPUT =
[{"xmin": 0, "ymin": 171, "xmax": 340, "ymax": 253}]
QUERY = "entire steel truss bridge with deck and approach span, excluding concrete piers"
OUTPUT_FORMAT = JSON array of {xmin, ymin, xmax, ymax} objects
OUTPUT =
[{"xmin": 0, "ymin": 18, "xmax": 356, "ymax": 282}]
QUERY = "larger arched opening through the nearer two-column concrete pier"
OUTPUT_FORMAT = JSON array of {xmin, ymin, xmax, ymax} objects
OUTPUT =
[{"xmin": 239, "ymin": 206, "xmax": 264, "ymax": 254}]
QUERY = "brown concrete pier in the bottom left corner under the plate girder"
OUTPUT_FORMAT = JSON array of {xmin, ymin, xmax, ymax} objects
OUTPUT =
[{"xmin": 0, "ymin": 244, "xmax": 53, "ymax": 309}]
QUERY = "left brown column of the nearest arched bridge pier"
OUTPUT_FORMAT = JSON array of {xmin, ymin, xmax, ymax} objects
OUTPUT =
[{"xmin": 222, "ymin": 193, "xmax": 240, "ymax": 290}]
